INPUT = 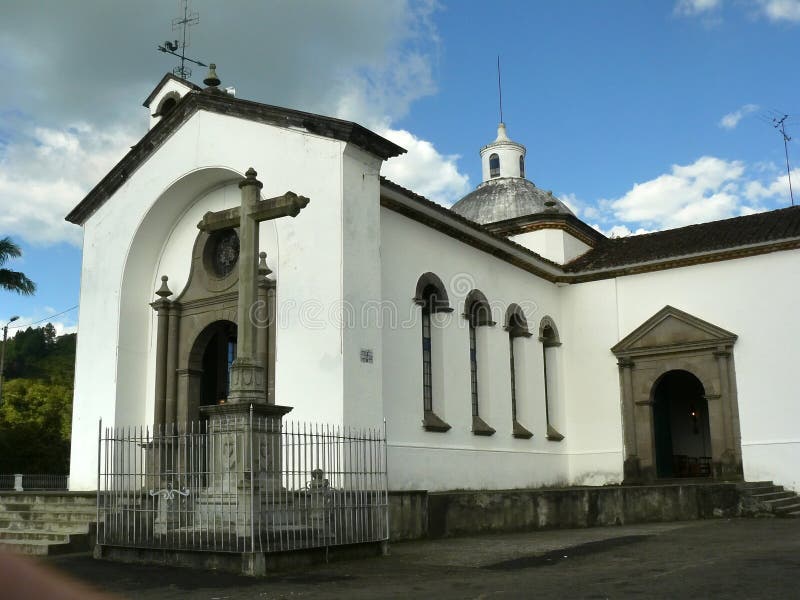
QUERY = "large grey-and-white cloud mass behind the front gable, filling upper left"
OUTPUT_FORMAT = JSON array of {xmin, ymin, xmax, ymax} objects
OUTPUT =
[{"xmin": 0, "ymin": 0, "xmax": 468, "ymax": 245}]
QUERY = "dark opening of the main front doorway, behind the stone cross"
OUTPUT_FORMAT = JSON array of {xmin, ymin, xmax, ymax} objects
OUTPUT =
[{"xmin": 189, "ymin": 320, "xmax": 236, "ymax": 406}]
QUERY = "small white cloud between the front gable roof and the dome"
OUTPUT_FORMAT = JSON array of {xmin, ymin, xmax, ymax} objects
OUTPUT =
[{"xmin": 378, "ymin": 129, "xmax": 470, "ymax": 205}]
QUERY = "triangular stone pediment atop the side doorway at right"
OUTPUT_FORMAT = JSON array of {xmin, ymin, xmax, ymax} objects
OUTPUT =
[{"xmin": 611, "ymin": 306, "xmax": 737, "ymax": 356}]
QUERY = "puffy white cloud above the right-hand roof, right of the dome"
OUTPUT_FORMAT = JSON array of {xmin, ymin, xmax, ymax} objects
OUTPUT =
[{"xmin": 599, "ymin": 156, "xmax": 800, "ymax": 233}]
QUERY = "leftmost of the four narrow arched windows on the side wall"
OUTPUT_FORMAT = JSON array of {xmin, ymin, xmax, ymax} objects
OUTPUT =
[{"xmin": 414, "ymin": 273, "xmax": 453, "ymax": 432}]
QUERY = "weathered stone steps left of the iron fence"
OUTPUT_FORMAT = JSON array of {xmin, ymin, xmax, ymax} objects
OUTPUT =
[{"xmin": 0, "ymin": 492, "xmax": 97, "ymax": 556}]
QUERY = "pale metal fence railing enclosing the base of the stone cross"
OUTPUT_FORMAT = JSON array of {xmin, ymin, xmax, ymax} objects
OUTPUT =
[{"xmin": 98, "ymin": 411, "xmax": 389, "ymax": 552}]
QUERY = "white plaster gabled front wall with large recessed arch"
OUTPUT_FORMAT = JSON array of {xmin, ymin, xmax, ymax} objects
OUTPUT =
[{"xmin": 70, "ymin": 112, "xmax": 376, "ymax": 489}]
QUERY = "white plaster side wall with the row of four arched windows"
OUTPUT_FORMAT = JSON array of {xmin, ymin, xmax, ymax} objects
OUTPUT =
[{"xmin": 381, "ymin": 208, "xmax": 569, "ymax": 490}]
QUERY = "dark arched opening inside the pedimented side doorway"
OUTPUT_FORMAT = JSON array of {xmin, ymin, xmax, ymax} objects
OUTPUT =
[{"xmin": 653, "ymin": 370, "xmax": 711, "ymax": 478}]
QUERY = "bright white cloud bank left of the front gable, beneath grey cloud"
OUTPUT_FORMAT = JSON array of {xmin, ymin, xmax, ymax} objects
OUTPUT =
[{"xmin": 0, "ymin": 123, "xmax": 135, "ymax": 246}]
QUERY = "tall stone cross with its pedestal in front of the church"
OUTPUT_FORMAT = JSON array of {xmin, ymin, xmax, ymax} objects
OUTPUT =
[{"xmin": 189, "ymin": 168, "xmax": 309, "ymax": 535}]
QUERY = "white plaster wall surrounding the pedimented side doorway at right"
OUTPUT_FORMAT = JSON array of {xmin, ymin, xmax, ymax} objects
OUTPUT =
[{"xmin": 561, "ymin": 251, "xmax": 800, "ymax": 490}]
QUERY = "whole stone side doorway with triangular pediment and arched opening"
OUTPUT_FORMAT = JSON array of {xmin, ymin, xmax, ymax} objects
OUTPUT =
[{"xmin": 611, "ymin": 306, "xmax": 742, "ymax": 483}]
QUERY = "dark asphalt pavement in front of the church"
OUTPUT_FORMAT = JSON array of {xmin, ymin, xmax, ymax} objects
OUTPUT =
[{"xmin": 37, "ymin": 519, "xmax": 800, "ymax": 600}]
